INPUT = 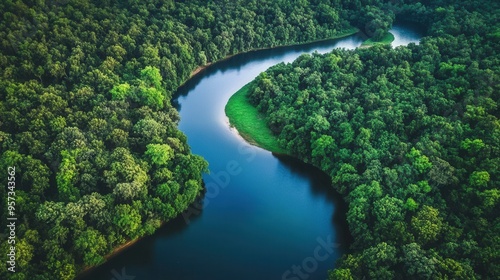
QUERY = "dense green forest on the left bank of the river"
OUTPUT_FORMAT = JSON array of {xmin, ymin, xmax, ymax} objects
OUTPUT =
[{"xmin": 0, "ymin": 0, "xmax": 416, "ymax": 279}]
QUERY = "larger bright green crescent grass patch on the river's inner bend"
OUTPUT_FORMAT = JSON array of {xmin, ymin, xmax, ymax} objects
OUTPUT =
[{"xmin": 225, "ymin": 83, "xmax": 287, "ymax": 154}]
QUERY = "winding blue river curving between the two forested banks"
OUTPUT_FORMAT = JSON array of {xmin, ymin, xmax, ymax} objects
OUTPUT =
[{"xmin": 86, "ymin": 23, "xmax": 418, "ymax": 280}]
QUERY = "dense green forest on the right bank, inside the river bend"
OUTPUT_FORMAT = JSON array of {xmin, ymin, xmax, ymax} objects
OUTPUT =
[{"xmin": 244, "ymin": 0, "xmax": 500, "ymax": 279}]
